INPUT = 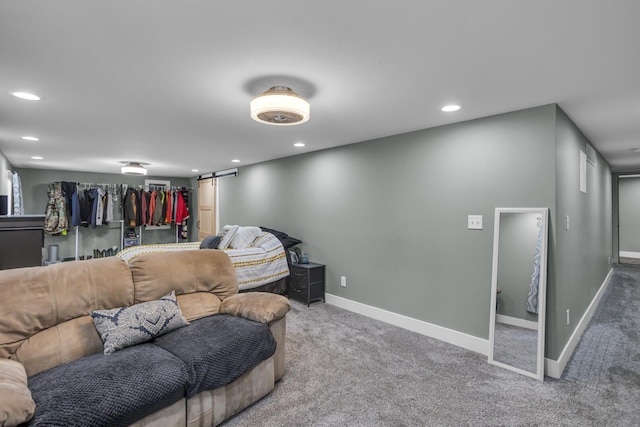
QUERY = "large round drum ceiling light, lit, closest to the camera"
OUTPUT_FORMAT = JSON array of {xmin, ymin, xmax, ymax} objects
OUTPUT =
[{"xmin": 249, "ymin": 86, "xmax": 311, "ymax": 126}]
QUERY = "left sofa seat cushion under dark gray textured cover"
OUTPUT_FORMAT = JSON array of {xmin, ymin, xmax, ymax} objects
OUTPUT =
[{"xmin": 29, "ymin": 343, "xmax": 188, "ymax": 426}]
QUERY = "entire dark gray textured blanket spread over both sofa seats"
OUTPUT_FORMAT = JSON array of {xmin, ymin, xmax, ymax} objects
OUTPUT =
[{"xmin": 28, "ymin": 315, "xmax": 276, "ymax": 427}]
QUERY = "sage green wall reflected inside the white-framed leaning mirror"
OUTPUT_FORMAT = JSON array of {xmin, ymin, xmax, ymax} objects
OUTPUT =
[{"xmin": 497, "ymin": 212, "xmax": 540, "ymax": 321}]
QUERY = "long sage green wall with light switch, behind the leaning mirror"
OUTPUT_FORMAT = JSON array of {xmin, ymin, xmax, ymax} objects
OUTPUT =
[{"xmin": 219, "ymin": 105, "xmax": 556, "ymax": 339}]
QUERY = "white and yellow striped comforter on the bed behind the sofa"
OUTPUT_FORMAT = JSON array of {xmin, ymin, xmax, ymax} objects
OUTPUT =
[{"xmin": 116, "ymin": 232, "xmax": 289, "ymax": 291}]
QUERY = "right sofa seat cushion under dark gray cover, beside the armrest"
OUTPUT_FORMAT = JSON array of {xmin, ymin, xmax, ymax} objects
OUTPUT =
[{"xmin": 153, "ymin": 314, "xmax": 276, "ymax": 397}]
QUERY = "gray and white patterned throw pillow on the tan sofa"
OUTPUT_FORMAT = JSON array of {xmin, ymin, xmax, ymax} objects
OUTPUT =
[{"xmin": 91, "ymin": 291, "xmax": 189, "ymax": 354}]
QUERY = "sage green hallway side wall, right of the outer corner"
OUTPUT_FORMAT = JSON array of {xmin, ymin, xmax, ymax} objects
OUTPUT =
[{"xmin": 546, "ymin": 108, "xmax": 613, "ymax": 360}]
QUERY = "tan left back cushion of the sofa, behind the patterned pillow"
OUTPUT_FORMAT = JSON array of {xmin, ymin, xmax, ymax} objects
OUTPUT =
[{"xmin": 0, "ymin": 257, "xmax": 134, "ymax": 376}]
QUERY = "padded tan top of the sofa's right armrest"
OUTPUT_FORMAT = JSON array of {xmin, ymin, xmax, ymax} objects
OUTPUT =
[{"xmin": 220, "ymin": 292, "xmax": 290, "ymax": 323}]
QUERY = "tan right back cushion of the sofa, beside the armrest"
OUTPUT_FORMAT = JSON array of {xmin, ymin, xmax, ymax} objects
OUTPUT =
[{"xmin": 129, "ymin": 249, "xmax": 238, "ymax": 321}]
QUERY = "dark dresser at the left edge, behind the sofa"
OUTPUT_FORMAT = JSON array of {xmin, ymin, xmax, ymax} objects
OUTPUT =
[{"xmin": 0, "ymin": 215, "xmax": 45, "ymax": 270}]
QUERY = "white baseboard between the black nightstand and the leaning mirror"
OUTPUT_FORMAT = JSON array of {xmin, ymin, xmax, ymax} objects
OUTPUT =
[{"xmin": 325, "ymin": 294, "xmax": 489, "ymax": 355}]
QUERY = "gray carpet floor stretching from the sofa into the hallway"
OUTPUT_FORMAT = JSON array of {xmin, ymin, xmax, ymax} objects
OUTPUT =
[{"xmin": 224, "ymin": 266, "xmax": 640, "ymax": 427}]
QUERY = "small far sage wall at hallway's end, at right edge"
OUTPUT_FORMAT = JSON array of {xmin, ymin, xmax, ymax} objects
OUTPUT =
[{"xmin": 618, "ymin": 178, "xmax": 640, "ymax": 252}]
